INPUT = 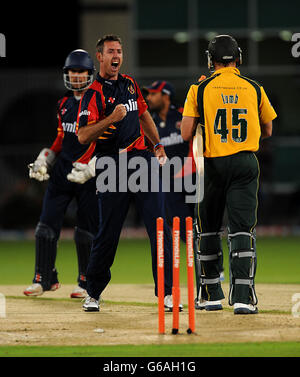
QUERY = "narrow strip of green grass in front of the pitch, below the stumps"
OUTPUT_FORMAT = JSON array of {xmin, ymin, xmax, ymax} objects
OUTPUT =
[{"xmin": 0, "ymin": 342, "xmax": 300, "ymax": 357}]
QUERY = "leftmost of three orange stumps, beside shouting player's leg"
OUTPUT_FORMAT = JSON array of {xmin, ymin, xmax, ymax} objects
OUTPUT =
[{"xmin": 156, "ymin": 217, "xmax": 165, "ymax": 334}]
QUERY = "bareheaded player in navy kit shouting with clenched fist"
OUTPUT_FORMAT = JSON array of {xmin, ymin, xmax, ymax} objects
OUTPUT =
[{"xmin": 78, "ymin": 35, "xmax": 176, "ymax": 311}]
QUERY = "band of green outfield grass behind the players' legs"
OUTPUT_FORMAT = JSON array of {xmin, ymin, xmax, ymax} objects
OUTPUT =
[{"xmin": 0, "ymin": 237, "xmax": 300, "ymax": 284}]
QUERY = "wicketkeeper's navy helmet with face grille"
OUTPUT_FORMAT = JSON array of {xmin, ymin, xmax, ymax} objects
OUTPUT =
[{"xmin": 63, "ymin": 49, "xmax": 95, "ymax": 91}]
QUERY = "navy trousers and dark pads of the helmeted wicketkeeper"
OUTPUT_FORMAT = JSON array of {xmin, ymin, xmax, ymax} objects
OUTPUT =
[{"xmin": 33, "ymin": 158, "xmax": 98, "ymax": 290}]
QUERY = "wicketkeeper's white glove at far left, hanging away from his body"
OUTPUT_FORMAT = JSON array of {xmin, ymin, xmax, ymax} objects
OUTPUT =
[{"xmin": 28, "ymin": 148, "xmax": 56, "ymax": 181}]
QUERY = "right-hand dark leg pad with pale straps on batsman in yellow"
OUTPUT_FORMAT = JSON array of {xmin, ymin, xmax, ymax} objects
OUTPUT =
[{"xmin": 228, "ymin": 232, "xmax": 257, "ymax": 305}]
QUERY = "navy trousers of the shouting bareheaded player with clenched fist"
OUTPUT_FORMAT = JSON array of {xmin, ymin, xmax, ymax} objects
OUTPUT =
[{"xmin": 87, "ymin": 151, "xmax": 172, "ymax": 299}]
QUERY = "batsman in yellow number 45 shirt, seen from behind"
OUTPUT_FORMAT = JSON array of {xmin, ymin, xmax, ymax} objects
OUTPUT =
[{"xmin": 181, "ymin": 35, "xmax": 277, "ymax": 314}]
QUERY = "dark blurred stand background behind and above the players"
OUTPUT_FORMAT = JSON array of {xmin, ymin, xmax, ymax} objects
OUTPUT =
[{"xmin": 0, "ymin": 0, "xmax": 300, "ymax": 229}]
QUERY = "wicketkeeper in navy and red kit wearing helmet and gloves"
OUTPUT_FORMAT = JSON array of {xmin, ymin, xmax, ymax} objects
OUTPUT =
[{"xmin": 24, "ymin": 49, "xmax": 98, "ymax": 298}]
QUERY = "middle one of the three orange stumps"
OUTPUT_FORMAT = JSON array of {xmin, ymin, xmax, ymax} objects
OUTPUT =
[{"xmin": 172, "ymin": 217, "xmax": 180, "ymax": 334}]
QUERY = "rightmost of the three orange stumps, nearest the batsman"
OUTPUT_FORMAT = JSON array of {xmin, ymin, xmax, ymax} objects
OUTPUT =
[{"xmin": 185, "ymin": 217, "xmax": 195, "ymax": 334}]
